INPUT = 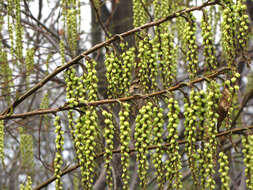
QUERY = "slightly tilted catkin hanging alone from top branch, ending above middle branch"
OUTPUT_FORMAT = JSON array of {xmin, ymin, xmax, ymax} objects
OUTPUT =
[{"xmin": 201, "ymin": 11, "xmax": 217, "ymax": 71}]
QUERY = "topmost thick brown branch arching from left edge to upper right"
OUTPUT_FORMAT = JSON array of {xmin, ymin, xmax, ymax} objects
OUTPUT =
[{"xmin": 1, "ymin": 0, "xmax": 219, "ymax": 115}]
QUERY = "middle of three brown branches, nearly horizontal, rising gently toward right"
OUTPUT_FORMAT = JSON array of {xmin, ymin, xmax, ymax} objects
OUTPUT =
[{"xmin": 0, "ymin": 67, "xmax": 230, "ymax": 120}]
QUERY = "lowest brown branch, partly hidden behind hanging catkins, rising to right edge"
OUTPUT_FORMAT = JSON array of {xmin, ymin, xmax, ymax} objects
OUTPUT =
[{"xmin": 33, "ymin": 125, "xmax": 253, "ymax": 190}]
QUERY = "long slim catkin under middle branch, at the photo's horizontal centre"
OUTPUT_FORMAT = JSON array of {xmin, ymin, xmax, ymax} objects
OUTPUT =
[{"xmin": 119, "ymin": 102, "xmax": 131, "ymax": 190}]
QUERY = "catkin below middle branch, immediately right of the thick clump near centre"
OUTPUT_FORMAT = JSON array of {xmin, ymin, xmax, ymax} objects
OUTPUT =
[{"xmin": 152, "ymin": 106, "xmax": 165, "ymax": 189}]
